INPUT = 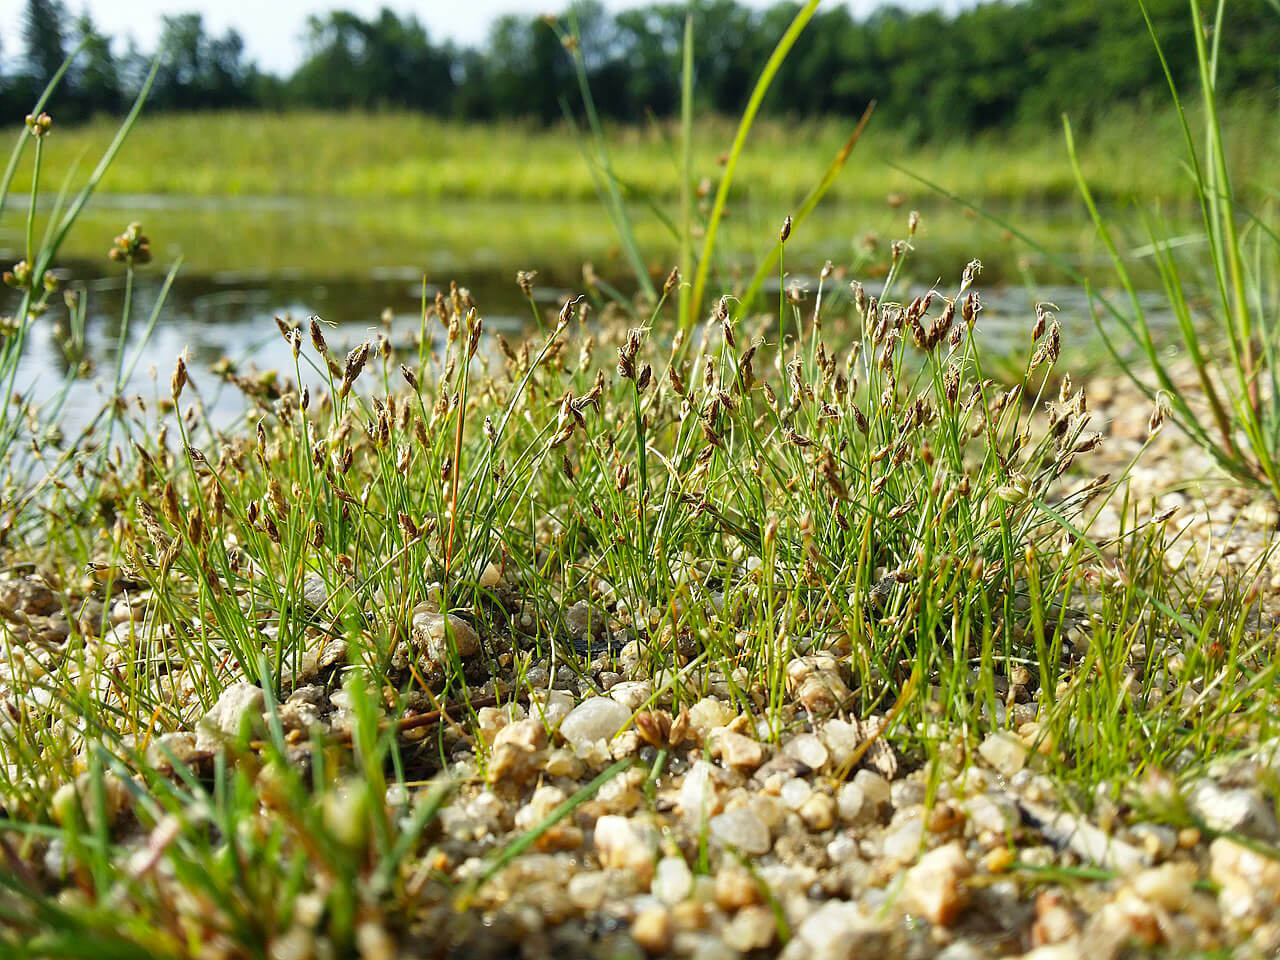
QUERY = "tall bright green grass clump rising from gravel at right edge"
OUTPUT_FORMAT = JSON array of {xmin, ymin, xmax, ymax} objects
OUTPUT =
[{"xmin": 1065, "ymin": 0, "xmax": 1280, "ymax": 500}]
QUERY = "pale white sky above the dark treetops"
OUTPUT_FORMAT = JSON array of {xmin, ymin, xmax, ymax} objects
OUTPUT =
[{"xmin": 0, "ymin": 0, "xmax": 960, "ymax": 73}]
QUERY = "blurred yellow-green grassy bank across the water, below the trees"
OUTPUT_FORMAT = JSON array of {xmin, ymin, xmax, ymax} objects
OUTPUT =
[{"xmin": 15, "ymin": 102, "xmax": 1280, "ymax": 205}]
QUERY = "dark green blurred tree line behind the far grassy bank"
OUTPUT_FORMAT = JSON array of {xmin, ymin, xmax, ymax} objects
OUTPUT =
[{"xmin": 0, "ymin": 0, "xmax": 1280, "ymax": 137}]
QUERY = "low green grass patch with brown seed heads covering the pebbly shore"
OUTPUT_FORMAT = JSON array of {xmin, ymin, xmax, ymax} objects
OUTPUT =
[{"xmin": 0, "ymin": 221, "xmax": 1277, "ymax": 955}]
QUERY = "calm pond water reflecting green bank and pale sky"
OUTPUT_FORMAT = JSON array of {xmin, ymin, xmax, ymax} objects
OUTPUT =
[{"xmin": 0, "ymin": 196, "xmax": 1172, "ymax": 429}]
